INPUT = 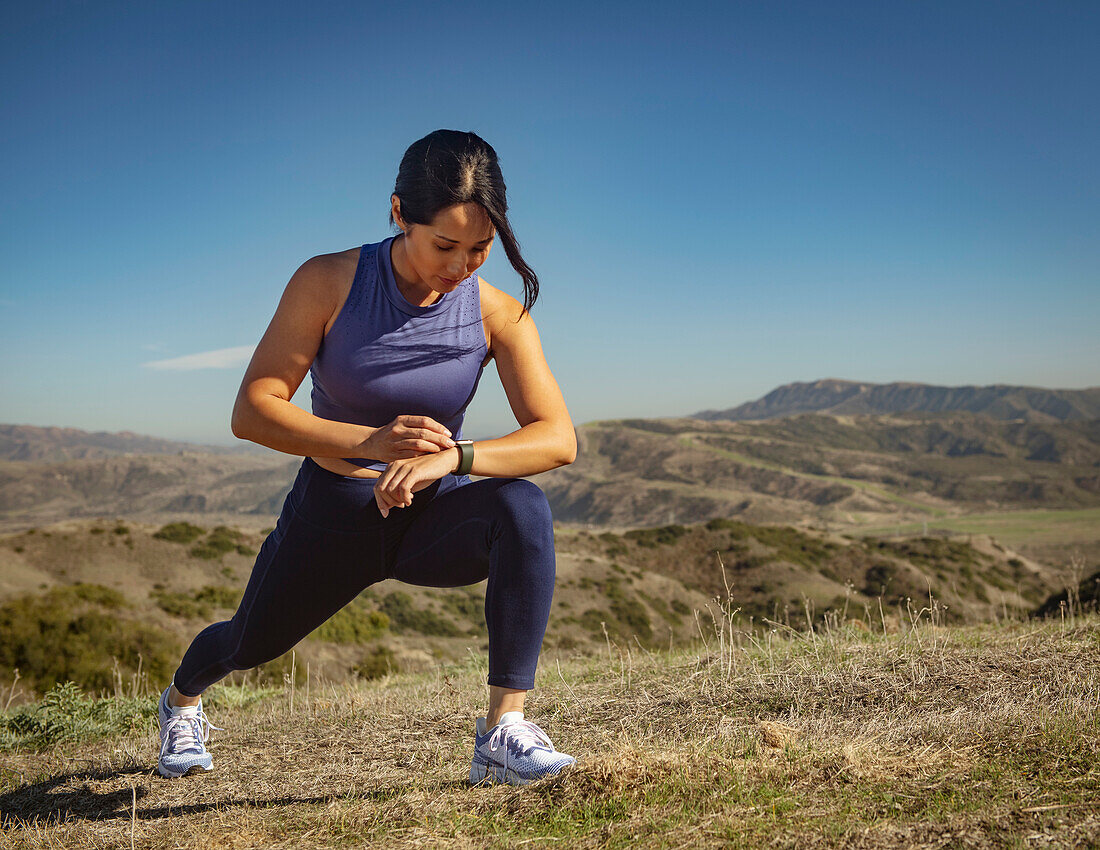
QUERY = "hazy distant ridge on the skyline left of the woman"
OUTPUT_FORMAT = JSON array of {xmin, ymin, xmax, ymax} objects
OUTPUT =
[{"xmin": 0, "ymin": 424, "xmax": 265, "ymax": 463}]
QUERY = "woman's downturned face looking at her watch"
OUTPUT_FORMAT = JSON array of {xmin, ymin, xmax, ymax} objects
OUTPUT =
[{"xmin": 392, "ymin": 195, "xmax": 495, "ymax": 303}]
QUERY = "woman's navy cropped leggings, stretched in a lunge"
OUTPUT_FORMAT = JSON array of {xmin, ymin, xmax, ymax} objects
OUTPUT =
[{"xmin": 175, "ymin": 457, "xmax": 554, "ymax": 696}]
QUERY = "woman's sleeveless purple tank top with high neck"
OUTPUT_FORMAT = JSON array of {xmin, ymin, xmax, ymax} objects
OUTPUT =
[{"xmin": 309, "ymin": 238, "xmax": 488, "ymax": 472}]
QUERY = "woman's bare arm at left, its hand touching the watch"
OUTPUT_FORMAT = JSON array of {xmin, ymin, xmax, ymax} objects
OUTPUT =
[{"xmin": 231, "ymin": 255, "xmax": 451, "ymax": 462}]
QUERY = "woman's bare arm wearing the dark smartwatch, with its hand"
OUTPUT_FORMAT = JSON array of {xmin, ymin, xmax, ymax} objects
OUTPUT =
[{"xmin": 374, "ymin": 289, "xmax": 576, "ymax": 516}]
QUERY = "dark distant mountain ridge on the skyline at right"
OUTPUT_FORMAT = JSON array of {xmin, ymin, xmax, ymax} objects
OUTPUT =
[{"xmin": 691, "ymin": 378, "xmax": 1100, "ymax": 422}]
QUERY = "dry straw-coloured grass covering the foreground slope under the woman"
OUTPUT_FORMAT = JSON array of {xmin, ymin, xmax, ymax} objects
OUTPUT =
[{"xmin": 0, "ymin": 608, "xmax": 1100, "ymax": 848}]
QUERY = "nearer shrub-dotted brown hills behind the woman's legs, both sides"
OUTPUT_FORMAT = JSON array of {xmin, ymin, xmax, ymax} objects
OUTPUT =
[{"xmin": 0, "ymin": 510, "xmax": 1064, "ymax": 696}]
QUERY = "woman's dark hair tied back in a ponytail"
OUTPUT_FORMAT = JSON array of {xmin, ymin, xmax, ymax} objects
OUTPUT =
[{"xmin": 389, "ymin": 130, "xmax": 539, "ymax": 312}]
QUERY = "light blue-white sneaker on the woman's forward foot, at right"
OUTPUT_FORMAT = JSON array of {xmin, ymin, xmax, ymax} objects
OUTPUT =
[{"xmin": 470, "ymin": 711, "xmax": 576, "ymax": 785}]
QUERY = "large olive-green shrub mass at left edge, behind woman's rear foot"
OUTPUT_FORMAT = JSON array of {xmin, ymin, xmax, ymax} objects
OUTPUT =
[{"xmin": 0, "ymin": 585, "xmax": 179, "ymax": 692}]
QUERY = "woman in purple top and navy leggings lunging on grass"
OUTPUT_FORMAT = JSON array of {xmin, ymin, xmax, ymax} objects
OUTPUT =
[{"xmin": 158, "ymin": 130, "xmax": 576, "ymax": 784}]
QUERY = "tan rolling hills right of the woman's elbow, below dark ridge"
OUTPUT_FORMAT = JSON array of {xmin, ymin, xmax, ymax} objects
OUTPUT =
[{"xmin": 537, "ymin": 412, "xmax": 1100, "ymax": 527}]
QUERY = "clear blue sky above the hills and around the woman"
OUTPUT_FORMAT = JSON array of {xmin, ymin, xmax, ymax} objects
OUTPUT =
[{"xmin": 0, "ymin": 0, "xmax": 1100, "ymax": 443}]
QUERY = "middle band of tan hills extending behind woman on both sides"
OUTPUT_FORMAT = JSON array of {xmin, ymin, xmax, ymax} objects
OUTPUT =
[{"xmin": 0, "ymin": 412, "xmax": 1100, "ymax": 541}]
